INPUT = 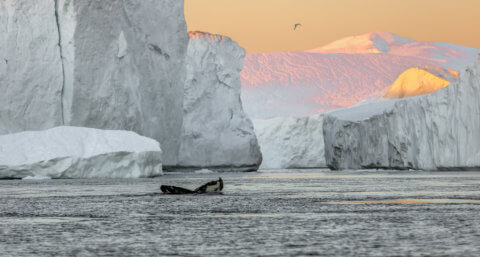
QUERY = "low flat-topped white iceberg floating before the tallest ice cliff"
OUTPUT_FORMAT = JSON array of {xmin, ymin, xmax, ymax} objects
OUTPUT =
[{"xmin": 0, "ymin": 127, "xmax": 162, "ymax": 178}]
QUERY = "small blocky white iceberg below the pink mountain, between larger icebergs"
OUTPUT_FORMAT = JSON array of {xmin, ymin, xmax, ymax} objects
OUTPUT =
[{"xmin": 253, "ymin": 114, "xmax": 326, "ymax": 169}]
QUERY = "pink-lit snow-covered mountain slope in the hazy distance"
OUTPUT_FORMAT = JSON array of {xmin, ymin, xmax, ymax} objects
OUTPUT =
[{"xmin": 241, "ymin": 32, "xmax": 480, "ymax": 119}]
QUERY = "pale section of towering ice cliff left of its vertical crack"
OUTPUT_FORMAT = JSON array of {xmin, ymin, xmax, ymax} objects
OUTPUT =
[{"xmin": 0, "ymin": 0, "xmax": 63, "ymax": 135}]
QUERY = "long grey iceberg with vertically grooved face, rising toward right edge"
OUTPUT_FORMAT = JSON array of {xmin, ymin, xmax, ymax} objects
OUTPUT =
[{"xmin": 323, "ymin": 64, "xmax": 480, "ymax": 170}]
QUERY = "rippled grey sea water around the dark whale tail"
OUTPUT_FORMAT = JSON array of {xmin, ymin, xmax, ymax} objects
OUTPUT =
[{"xmin": 0, "ymin": 171, "xmax": 480, "ymax": 256}]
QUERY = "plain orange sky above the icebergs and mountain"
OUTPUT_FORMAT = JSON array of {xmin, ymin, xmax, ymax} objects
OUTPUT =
[{"xmin": 185, "ymin": 0, "xmax": 480, "ymax": 52}]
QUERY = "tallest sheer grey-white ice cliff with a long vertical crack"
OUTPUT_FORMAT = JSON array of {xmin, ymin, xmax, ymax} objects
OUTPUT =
[{"xmin": 0, "ymin": 0, "xmax": 188, "ymax": 165}]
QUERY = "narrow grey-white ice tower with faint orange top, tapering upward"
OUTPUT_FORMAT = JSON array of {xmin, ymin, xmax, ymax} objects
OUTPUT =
[{"xmin": 178, "ymin": 32, "xmax": 262, "ymax": 170}]
